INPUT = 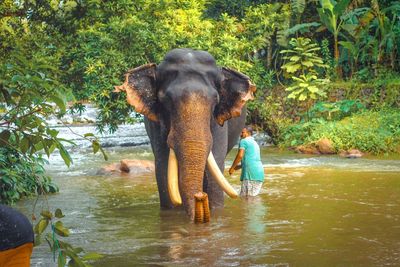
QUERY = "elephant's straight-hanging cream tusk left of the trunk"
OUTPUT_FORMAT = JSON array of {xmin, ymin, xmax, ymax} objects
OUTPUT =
[{"xmin": 168, "ymin": 148, "xmax": 182, "ymax": 206}]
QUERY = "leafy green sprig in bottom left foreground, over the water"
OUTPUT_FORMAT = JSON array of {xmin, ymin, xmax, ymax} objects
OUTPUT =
[{"xmin": 34, "ymin": 209, "xmax": 103, "ymax": 267}]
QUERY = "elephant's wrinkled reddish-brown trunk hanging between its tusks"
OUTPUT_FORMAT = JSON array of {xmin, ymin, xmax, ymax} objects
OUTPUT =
[{"xmin": 168, "ymin": 95, "xmax": 212, "ymax": 219}]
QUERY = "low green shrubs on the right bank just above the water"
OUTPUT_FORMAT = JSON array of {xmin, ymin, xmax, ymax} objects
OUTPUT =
[{"xmin": 280, "ymin": 109, "xmax": 400, "ymax": 154}]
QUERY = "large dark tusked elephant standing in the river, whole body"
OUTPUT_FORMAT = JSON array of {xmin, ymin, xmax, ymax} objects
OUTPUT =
[{"xmin": 114, "ymin": 48, "xmax": 256, "ymax": 219}]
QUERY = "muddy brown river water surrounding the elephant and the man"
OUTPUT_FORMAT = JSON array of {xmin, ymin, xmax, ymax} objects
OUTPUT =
[{"xmin": 16, "ymin": 146, "xmax": 400, "ymax": 267}]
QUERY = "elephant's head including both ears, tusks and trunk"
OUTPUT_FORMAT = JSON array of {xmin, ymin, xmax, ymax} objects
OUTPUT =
[{"xmin": 115, "ymin": 49, "xmax": 255, "ymax": 221}]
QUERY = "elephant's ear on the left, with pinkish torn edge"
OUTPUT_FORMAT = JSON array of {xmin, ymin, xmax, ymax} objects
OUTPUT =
[{"xmin": 114, "ymin": 63, "xmax": 158, "ymax": 121}]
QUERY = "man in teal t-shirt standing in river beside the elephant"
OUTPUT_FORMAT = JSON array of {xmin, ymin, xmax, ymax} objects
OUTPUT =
[{"xmin": 229, "ymin": 126, "xmax": 264, "ymax": 197}]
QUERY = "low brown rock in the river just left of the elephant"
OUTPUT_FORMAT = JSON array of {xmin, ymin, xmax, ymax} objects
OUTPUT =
[{"xmin": 97, "ymin": 159, "xmax": 154, "ymax": 176}]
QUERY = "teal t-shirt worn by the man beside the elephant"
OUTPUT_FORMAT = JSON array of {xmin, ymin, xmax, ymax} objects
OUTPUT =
[{"xmin": 239, "ymin": 136, "xmax": 264, "ymax": 182}]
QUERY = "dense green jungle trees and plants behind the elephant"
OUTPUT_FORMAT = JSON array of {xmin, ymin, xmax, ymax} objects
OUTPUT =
[{"xmin": 0, "ymin": 0, "xmax": 400, "ymax": 203}]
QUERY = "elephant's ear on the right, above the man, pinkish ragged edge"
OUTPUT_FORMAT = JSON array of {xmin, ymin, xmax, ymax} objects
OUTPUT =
[{"xmin": 214, "ymin": 67, "xmax": 256, "ymax": 126}]
